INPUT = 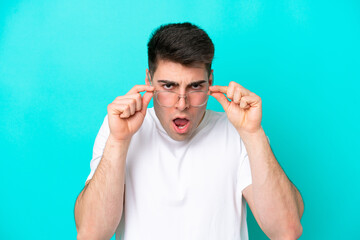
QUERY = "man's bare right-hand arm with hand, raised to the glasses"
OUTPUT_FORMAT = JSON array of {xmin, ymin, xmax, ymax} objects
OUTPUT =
[{"xmin": 209, "ymin": 82, "xmax": 304, "ymax": 239}]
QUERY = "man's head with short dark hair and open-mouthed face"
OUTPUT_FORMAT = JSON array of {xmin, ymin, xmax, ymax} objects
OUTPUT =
[{"xmin": 146, "ymin": 23, "xmax": 214, "ymax": 141}]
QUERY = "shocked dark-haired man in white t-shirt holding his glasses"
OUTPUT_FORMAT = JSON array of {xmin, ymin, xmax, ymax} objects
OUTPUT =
[{"xmin": 75, "ymin": 23, "xmax": 304, "ymax": 240}]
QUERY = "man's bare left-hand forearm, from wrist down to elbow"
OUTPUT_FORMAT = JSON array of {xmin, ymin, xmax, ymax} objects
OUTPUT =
[{"xmin": 75, "ymin": 137, "xmax": 130, "ymax": 239}]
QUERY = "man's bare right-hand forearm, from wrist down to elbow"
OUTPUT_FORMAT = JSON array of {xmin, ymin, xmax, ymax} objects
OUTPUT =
[{"xmin": 241, "ymin": 129, "xmax": 303, "ymax": 239}]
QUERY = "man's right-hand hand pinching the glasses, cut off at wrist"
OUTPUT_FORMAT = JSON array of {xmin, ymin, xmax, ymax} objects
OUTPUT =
[{"xmin": 209, "ymin": 82, "xmax": 262, "ymax": 134}]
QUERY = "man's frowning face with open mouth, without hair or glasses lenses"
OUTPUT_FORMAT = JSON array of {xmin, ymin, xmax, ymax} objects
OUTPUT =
[{"xmin": 146, "ymin": 60, "xmax": 212, "ymax": 141}]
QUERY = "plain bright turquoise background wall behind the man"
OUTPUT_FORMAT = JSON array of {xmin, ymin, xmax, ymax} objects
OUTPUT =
[{"xmin": 0, "ymin": 0, "xmax": 360, "ymax": 239}]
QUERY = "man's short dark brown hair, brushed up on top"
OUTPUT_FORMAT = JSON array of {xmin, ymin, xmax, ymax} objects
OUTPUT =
[{"xmin": 147, "ymin": 22, "xmax": 215, "ymax": 76}]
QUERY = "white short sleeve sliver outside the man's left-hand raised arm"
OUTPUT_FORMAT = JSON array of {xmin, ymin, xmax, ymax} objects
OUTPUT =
[{"xmin": 86, "ymin": 115, "xmax": 110, "ymax": 181}]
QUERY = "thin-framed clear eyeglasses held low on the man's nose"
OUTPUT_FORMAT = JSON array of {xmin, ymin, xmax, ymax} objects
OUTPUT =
[{"xmin": 154, "ymin": 90, "xmax": 209, "ymax": 107}]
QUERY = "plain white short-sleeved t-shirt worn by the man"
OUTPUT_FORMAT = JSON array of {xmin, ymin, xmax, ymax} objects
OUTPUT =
[{"xmin": 88, "ymin": 108, "xmax": 252, "ymax": 240}]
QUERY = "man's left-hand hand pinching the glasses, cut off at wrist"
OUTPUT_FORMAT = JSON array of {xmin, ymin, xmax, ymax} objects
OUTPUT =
[{"xmin": 107, "ymin": 85, "xmax": 154, "ymax": 141}]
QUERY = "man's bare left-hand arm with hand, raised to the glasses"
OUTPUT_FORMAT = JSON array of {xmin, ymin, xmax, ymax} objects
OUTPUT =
[{"xmin": 74, "ymin": 85, "xmax": 154, "ymax": 240}]
